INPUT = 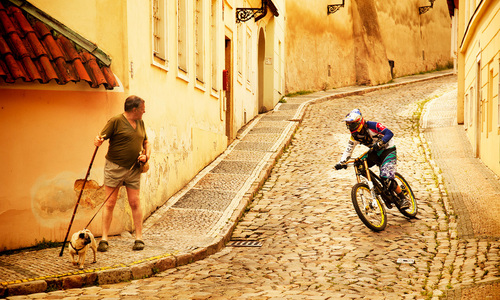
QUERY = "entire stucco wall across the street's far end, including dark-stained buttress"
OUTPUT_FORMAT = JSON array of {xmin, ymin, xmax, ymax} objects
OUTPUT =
[{"xmin": 285, "ymin": 0, "xmax": 451, "ymax": 93}]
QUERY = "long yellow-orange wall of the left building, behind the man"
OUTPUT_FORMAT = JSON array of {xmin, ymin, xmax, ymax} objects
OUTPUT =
[{"xmin": 0, "ymin": 0, "xmax": 284, "ymax": 251}]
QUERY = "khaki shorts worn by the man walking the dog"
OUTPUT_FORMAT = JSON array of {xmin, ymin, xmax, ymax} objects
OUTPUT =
[{"xmin": 104, "ymin": 159, "xmax": 141, "ymax": 190}]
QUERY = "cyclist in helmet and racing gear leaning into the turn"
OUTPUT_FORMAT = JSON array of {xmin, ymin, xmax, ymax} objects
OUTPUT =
[{"xmin": 335, "ymin": 109, "xmax": 410, "ymax": 209}]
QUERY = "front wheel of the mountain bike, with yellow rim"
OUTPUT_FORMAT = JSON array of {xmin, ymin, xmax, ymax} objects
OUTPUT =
[{"xmin": 351, "ymin": 183, "xmax": 387, "ymax": 232}]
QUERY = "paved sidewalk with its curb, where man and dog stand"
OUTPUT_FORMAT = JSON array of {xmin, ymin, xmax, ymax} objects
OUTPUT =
[{"xmin": 0, "ymin": 71, "xmax": 476, "ymax": 297}]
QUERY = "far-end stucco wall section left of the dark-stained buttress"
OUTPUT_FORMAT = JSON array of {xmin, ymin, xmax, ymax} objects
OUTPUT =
[{"xmin": 285, "ymin": 0, "xmax": 356, "ymax": 93}]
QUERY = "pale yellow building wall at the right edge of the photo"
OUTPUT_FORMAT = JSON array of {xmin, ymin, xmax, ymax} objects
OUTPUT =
[{"xmin": 457, "ymin": 1, "xmax": 500, "ymax": 175}]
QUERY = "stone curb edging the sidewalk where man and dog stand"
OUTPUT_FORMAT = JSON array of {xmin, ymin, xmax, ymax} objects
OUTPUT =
[{"xmin": 0, "ymin": 72, "xmax": 454, "ymax": 298}]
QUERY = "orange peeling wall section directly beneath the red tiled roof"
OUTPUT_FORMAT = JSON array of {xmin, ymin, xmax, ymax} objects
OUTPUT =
[{"xmin": 0, "ymin": 83, "xmax": 125, "ymax": 251}]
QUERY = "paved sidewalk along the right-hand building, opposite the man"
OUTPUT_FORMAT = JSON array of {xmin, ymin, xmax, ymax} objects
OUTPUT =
[{"xmin": 420, "ymin": 84, "xmax": 500, "ymax": 300}]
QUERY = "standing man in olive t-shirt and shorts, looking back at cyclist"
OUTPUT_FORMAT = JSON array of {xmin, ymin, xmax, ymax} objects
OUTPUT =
[{"xmin": 94, "ymin": 96, "xmax": 151, "ymax": 252}]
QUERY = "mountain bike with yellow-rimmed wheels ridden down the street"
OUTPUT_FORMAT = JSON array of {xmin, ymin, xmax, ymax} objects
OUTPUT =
[{"xmin": 336, "ymin": 150, "xmax": 418, "ymax": 231}]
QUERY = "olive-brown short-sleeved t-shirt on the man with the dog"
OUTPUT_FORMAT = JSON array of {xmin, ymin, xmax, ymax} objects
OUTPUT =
[{"xmin": 101, "ymin": 114, "xmax": 148, "ymax": 169}]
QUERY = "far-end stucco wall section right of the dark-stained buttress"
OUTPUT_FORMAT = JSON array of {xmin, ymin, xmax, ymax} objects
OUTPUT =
[{"xmin": 375, "ymin": 0, "xmax": 452, "ymax": 77}]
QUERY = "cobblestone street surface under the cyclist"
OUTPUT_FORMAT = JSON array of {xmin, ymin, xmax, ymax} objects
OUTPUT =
[{"xmin": 9, "ymin": 76, "xmax": 500, "ymax": 299}]
